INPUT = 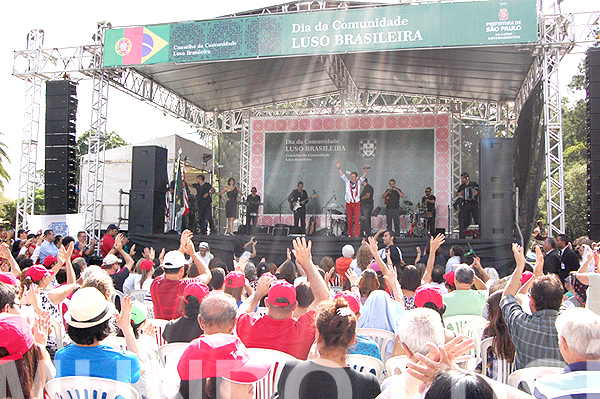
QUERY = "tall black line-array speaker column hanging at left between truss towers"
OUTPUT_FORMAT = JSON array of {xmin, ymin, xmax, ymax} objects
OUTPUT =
[{"xmin": 44, "ymin": 80, "xmax": 77, "ymax": 215}]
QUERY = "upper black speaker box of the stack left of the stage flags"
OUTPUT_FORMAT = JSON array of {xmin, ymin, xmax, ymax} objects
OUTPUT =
[{"xmin": 131, "ymin": 145, "xmax": 169, "ymax": 192}]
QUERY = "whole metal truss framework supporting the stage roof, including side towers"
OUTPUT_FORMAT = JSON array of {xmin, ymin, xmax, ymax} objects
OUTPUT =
[{"xmin": 13, "ymin": 0, "xmax": 592, "ymax": 235}]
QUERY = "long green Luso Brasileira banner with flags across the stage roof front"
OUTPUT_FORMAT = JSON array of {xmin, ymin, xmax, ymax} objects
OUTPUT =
[{"xmin": 104, "ymin": 0, "xmax": 538, "ymax": 67}]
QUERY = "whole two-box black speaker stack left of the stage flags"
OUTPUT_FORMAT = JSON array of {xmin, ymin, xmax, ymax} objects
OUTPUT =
[{"xmin": 129, "ymin": 145, "xmax": 168, "ymax": 235}]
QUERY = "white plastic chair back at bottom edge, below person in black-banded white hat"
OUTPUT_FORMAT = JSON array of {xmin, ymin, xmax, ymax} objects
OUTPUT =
[{"xmin": 46, "ymin": 377, "xmax": 140, "ymax": 399}]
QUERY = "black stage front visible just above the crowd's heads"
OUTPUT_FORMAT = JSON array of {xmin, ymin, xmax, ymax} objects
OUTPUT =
[{"xmin": 129, "ymin": 234, "xmax": 514, "ymax": 277}]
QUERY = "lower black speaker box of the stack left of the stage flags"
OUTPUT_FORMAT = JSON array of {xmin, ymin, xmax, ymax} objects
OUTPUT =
[{"xmin": 128, "ymin": 190, "xmax": 165, "ymax": 235}]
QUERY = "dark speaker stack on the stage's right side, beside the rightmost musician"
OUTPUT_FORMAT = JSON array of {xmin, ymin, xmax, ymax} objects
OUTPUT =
[{"xmin": 479, "ymin": 137, "xmax": 515, "ymax": 240}]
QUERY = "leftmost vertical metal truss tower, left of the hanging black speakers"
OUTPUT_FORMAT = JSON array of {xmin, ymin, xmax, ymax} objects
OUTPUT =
[{"xmin": 15, "ymin": 29, "xmax": 44, "ymax": 230}]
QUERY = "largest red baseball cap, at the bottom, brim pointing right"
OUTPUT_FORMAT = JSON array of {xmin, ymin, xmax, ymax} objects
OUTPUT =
[{"xmin": 177, "ymin": 334, "xmax": 273, "ymax": 384}]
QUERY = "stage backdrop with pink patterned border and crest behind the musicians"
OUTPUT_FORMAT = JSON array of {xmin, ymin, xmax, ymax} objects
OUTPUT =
[{"xmin": 244, "ymin": 114, "xmax": 452, "ymax": 229}]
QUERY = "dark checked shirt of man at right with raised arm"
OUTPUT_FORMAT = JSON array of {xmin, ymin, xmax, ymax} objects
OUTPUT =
[{"xmin": 500, "ymin": 295, "xmax": 565, "ymax": 370}]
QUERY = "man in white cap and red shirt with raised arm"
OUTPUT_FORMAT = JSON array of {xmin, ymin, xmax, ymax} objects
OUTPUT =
[{"xmin": 150, "ymin": 230, "xmax": 211, "ymax": 320}]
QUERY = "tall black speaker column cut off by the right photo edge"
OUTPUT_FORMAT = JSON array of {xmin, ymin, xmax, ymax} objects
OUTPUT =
[{"xmin": 585, "ymin": 48, "xmax": 600, "ymax": 240}]
